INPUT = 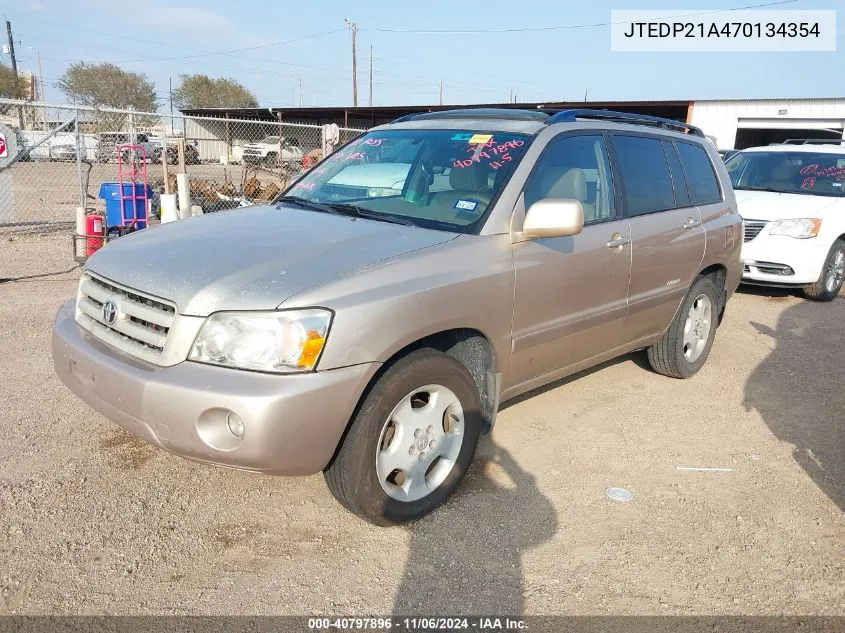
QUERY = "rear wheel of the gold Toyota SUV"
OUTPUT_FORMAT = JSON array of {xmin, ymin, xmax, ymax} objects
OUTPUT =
[{"xmin": 648, "ymin": 277, "xmax": 719, "ymax": 378}]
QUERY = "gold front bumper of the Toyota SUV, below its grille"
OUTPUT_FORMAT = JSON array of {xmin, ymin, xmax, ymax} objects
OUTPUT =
[{"xmin": 52, "ymin": 301, "xmax": 380, "ymax": 475}]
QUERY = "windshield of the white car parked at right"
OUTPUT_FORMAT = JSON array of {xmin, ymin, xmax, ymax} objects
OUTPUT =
[{"xmin": 725, "ymin": 151, "xmax": 845, "ymax": 196}]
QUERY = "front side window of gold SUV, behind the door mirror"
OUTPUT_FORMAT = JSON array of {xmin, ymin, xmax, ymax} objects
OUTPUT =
[{"xmin": 525, "ymin": 135, "xmax": 615, "ymax": 224}]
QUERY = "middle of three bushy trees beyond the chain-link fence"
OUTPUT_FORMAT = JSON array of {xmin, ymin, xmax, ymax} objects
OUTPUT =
[{"xmin": 58, "ymin": 62, "xmax": 158, "ymax": 112}]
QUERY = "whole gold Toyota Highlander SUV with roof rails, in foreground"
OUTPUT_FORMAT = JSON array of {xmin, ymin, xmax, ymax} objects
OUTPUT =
[{"xmin": 52, "ymin": 110, "xmax": 742, "ymax": 524}]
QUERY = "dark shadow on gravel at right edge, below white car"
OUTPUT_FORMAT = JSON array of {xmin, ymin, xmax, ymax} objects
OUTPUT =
[{"xmin": 743, "ymin": 295, "xmax": 845, "ymax": 512}]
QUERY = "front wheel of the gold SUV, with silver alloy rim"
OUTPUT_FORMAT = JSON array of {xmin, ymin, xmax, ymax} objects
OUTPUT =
[{"xmin": 323, "ymin": 349, "xmax": 482, "ymax": 525}]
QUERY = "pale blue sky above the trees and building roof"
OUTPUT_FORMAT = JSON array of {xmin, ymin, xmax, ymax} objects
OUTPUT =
[{"xmin": 0, "ymin": 0, "xmax": 845, "ymax": 111}]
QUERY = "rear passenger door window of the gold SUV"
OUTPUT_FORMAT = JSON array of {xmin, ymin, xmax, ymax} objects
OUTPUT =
[{"xmin": 613, "ymin": 135, "xmax": 675, "ymax": 216}]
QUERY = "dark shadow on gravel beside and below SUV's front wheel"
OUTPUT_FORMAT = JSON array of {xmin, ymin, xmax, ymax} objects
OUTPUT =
[{"xmin": 393, "ymin": 437, "xmax": 557, "ymax": 616}]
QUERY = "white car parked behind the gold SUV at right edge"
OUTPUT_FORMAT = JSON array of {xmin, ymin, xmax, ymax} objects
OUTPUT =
[{"xmin": 725, "ymin": 141, "xmax": 845, "ymax": 301}]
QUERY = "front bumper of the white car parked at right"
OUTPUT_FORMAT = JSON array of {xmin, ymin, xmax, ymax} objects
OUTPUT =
[{"xmin": 742, "ymin": 232, "xmax": 830, "ymax": 285}]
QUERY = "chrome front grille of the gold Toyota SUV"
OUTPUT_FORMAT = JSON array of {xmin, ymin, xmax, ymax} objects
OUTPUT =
[{"xmin": 76, "ymin": 273, "xmax": 176, "ymax": 364}]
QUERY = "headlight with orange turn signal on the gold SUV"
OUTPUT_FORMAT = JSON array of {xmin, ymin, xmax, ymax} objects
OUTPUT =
[{"xmin": 188, "ymin": 309, "xmax": 332, "ymax": 374}]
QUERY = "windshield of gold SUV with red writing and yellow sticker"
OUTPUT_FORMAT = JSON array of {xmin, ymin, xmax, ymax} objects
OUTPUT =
[{"xmin": 285, "ymin": 129, "xmax": 531, "ymax": 233}]
